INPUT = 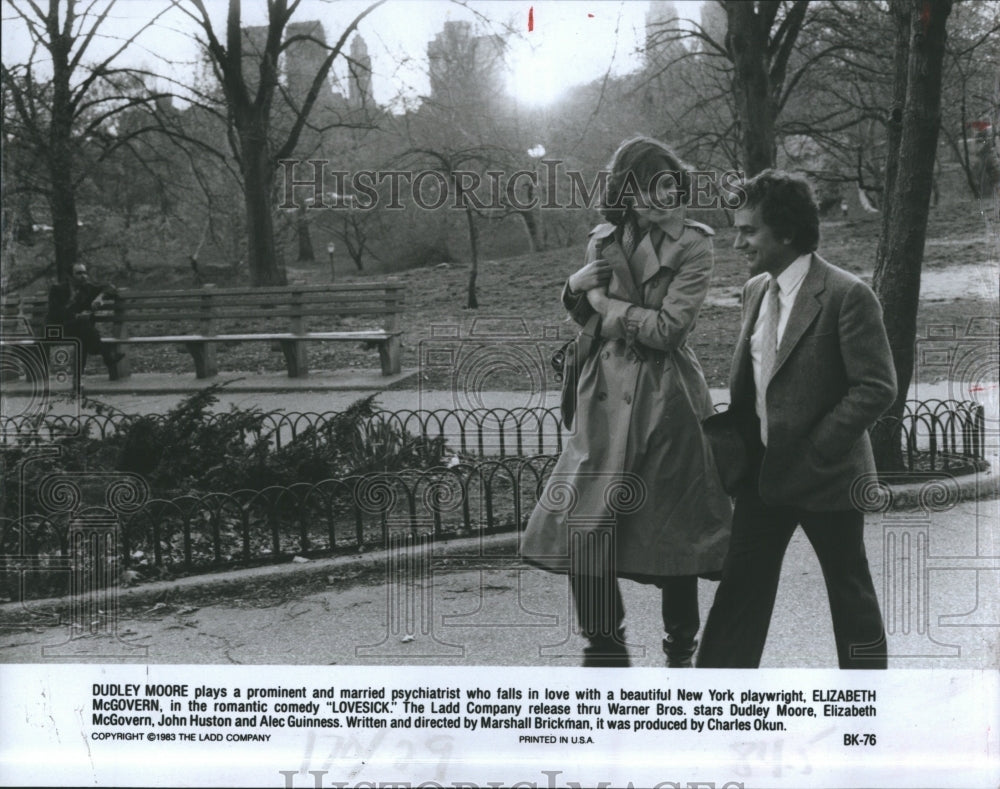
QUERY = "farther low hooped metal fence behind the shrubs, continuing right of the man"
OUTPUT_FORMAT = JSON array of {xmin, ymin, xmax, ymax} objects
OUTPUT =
[{"xmin": 0, "ymin": 400, "xmax": 986, "ymax": 471}]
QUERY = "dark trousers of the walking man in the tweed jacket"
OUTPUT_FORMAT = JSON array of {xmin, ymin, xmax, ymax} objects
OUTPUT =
[{"xmin": 697, "ymin": 484, "xmax": 886, "ymax": 669}]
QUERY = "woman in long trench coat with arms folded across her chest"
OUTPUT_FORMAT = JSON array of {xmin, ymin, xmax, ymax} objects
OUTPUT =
[{"xmin": 522, "ymin": 137, "xmax": 732, "ymax": 667}]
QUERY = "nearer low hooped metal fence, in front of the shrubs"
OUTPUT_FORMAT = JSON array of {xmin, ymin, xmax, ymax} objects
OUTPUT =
[{"xmin": 0, "ymin": 455, "xmax": 556, "ymax": 600}]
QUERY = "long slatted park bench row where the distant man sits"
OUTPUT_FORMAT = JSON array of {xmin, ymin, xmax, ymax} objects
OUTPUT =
[{"xmin": 0, "ymin": 280, "xmax": 404, "ymax": 380}]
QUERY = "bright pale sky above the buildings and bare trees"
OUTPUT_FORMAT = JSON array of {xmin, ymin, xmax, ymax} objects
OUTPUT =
[{"xmin": 2, "ymin": 0, "xmax": 702, "ymax": 104}]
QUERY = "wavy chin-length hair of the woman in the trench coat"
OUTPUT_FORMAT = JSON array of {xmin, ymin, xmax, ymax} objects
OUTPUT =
[{"xmin": 601, "ymin": 137, "xmax": 691, "ymax": 225}]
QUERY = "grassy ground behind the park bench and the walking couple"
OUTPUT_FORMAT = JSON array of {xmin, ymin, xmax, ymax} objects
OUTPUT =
[{"xmin": 64, "ymin": 201, "xmax": 997, "ymax": 390}]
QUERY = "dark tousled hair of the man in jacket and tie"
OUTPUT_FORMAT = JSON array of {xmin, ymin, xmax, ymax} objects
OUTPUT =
[{"xmin": 743, "ymin": 170, "xmax": 819, "ymax": 255}]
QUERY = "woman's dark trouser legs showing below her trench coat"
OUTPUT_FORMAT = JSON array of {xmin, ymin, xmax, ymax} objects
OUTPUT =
[{"xmin": 570, "ymin": 571, "xmax": 701, "ymax": 643}]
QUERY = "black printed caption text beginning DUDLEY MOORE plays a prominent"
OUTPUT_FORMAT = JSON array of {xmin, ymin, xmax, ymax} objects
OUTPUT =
[{"xmin": 90, "ymin": 683, "xmax": 878, "ymax": 746}]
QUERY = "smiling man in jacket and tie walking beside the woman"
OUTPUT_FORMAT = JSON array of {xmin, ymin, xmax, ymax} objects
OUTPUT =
[{"xmin": 697, "ymin": 170, "xmax": 896, "ymax": 669}]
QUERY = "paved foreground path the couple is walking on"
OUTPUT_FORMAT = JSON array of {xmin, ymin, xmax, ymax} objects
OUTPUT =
[{"xmin": 0, "ymin": 501, "xmax": 1000, "ymax": 669}]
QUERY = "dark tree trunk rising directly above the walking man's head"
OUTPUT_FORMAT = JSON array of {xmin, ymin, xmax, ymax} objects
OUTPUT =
[{"xmin": 726, "ymin": 2, "xmax": 777, "ymax": 178}]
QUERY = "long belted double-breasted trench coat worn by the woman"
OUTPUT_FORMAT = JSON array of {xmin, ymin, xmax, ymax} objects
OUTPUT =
[{"xmin": 521, "ymin": 209, "xmax": 732, "ymax": 583}]
